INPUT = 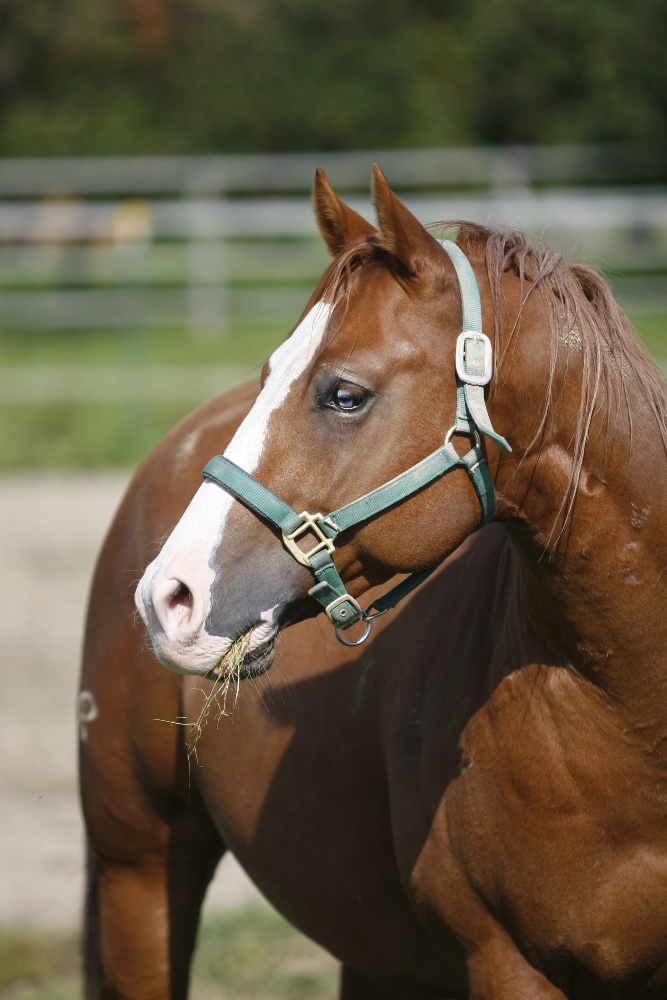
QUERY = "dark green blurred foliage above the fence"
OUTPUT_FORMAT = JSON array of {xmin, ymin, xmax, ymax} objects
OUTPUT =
[{"xmin": 0, "ymin": 0, "xmax": 667, "ymax": 155}]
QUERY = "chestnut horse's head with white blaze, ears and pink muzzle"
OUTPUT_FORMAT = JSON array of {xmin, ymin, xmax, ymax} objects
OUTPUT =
[{"xmin": 136, "ymin": 167, "xmax": 514, "ymax": 676}]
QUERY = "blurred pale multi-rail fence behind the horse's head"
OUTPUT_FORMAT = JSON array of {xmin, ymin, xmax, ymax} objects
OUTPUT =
[{"xmin": 0, "ymin": 144, "xmax": 667, "ymax": 402}]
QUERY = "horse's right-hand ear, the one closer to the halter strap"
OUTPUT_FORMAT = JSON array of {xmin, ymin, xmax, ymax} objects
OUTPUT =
[{"xmin": 373, "ymin": 163, "xmax": 443, "ymax": 274}]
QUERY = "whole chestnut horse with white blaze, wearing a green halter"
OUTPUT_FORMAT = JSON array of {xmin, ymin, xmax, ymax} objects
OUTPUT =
[{"xmin": 81, "ymin": 167, "xmax": 667, "ymax": 1000}]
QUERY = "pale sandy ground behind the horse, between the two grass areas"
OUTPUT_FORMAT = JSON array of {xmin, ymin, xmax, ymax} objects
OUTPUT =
[{"xmin": 0, "ymin": 473, "xmax": 261, "ymax": 926}]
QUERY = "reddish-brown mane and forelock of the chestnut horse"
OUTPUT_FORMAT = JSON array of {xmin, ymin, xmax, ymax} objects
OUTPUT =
[{"xmin": 322, "ymin": 221, "xmax": 667, "ymax": 536}]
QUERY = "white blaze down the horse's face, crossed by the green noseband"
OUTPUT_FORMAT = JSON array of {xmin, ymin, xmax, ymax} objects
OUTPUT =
[{"xmin": 136, "ymin": 302, "xmax": 331, "ymax": 659}]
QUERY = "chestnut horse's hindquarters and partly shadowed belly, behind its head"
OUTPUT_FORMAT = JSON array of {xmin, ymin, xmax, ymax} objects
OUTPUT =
[{"xmin": 82, "ymin": 385, "xmax": 474, "ymax": 996}]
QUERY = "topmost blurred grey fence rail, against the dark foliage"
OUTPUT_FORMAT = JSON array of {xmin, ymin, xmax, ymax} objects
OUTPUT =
[{"xmin": 0, "ymin": 143, "xmax": 667, "ymax": 198}]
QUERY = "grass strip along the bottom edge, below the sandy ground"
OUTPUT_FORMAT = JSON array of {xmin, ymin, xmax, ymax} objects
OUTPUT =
[{"xmin": 0, "ymin": 906, "xmax": 337, "ymax": 1000}]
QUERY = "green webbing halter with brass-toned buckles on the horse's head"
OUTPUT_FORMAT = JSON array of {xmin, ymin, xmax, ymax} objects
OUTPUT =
[{"xmin": 203, "ymin": 240, "xmax": 512, "ymax": 646}]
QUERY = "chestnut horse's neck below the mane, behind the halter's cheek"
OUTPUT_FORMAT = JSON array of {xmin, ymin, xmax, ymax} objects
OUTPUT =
[{"xmin": 498, "ymin": 364, "xmax": 667, "ymax": 728}]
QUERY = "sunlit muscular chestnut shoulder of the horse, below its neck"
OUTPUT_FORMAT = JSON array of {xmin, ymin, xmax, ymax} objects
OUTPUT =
[{"xmin": 412, "ymin": 604, "xmax": 667, "ymax": 984}]
